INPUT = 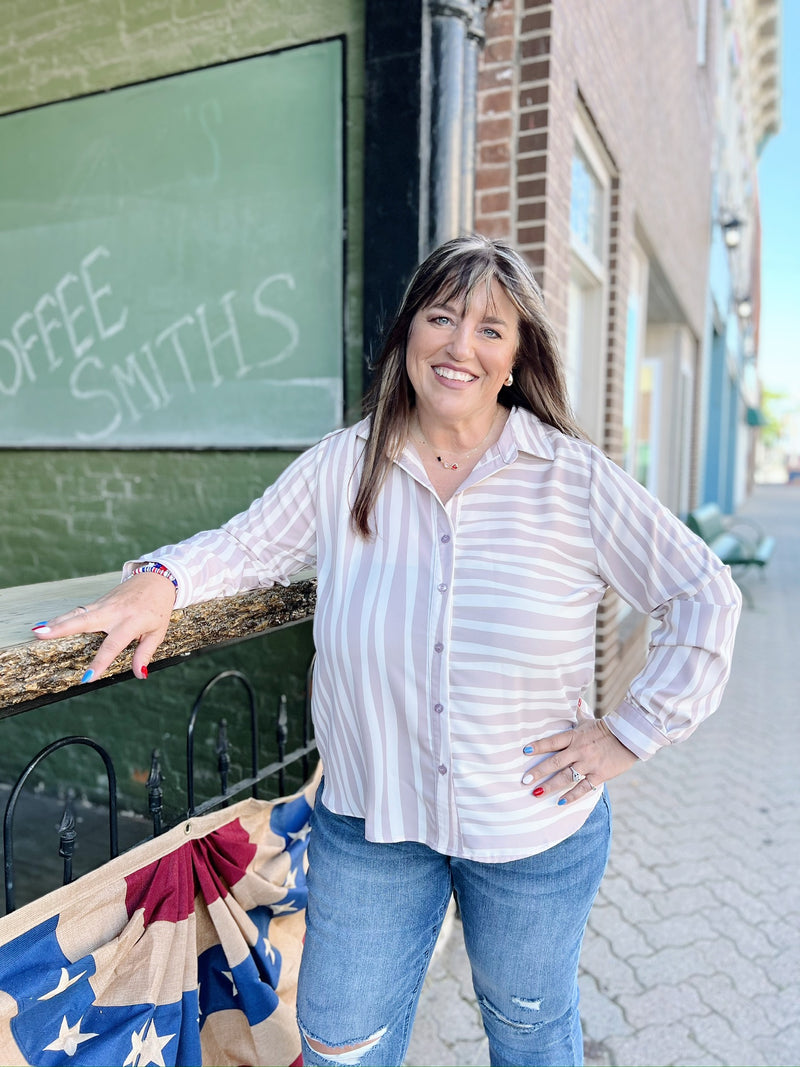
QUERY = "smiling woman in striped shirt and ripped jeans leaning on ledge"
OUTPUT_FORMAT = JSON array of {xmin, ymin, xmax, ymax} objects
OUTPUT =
[{"xmin": 32, "ymin": 237, "xmax": 740, "ymax": 1065}]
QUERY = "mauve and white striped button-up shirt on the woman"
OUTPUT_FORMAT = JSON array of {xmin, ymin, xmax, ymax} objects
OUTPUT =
[{"xmin": 134, "ymin": 409, "xmax": 740, "ymax": 861}]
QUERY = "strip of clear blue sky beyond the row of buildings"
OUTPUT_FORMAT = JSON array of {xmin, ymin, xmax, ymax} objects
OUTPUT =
[{"xmin": 758, "ymin": 0, "xmax": 800, "ymax": 403}]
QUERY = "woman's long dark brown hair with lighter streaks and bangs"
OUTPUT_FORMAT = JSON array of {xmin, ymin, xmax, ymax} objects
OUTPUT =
[{"xmin": 352, "ymin": 234, "xmax": 583, "ymax": 539}]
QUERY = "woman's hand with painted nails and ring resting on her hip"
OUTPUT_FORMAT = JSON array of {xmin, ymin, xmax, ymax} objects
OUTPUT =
[{"xmin": 523, "ymin": 719, "xmax": 639, "ymax": 803}]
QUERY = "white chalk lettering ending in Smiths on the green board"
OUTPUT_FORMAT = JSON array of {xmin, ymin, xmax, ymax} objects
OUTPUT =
[{"xmin": 0, "ymin": 245, "xmax": 300, "ymax": 442}]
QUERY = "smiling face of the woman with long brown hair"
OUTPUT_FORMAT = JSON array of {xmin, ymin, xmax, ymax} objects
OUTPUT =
[{"xmin": 405, "ymin": 281, "xmax": 519, "ymax": 429}]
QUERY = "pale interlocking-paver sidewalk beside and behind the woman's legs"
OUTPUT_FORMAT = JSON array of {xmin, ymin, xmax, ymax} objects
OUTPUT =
[{"xmin": 405, "ymin": 485, "xmax": 800, "ymax": 1067}]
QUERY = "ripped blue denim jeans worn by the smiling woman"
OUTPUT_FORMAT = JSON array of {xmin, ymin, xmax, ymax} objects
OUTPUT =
[{"xmin": 298, "ymin": 795, "xmax": 611, "ymax": 1067}]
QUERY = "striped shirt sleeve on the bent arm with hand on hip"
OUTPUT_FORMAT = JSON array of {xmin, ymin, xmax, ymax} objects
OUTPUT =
[{"xmin": 590, "ymin": 453, "xmax": 741, "ymax": 759}]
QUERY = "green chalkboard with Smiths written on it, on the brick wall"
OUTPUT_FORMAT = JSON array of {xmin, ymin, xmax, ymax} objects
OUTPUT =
[{"xmin": 0, "ymin": 41, "xmax": 343, "ymax": 448}]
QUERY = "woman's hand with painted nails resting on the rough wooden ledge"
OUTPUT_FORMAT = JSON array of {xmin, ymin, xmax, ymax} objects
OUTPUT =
[{"xmin": 33, "ymin": 573, "xmax": 175, "ymax": 682}]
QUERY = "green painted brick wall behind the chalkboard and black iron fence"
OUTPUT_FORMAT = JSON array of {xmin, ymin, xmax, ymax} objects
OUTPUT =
[{"xmin": 0, "ymin": 0, "xmax": 364, "ymax": 810}]
